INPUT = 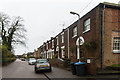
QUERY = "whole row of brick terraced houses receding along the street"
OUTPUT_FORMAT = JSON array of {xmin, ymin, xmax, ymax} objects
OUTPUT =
[{"xmin": 33, "ymin": 3, "xmax": 120, "ymax": 72}]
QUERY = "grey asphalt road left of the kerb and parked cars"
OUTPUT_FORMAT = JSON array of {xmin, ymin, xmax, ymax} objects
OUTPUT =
[{"xmin": 2, "ymin": 59, "xmax": 46, "ymax": 78}]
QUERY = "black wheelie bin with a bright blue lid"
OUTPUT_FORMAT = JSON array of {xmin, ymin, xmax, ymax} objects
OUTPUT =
[{"xmin": 74, "ymin": 62, "xmax": 86, "ymax": 76}]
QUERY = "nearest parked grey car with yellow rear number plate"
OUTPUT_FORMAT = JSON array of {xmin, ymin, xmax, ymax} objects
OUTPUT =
[{"xmin": 34, "ymin": 59, "xmax": 52, "ymax": 73}]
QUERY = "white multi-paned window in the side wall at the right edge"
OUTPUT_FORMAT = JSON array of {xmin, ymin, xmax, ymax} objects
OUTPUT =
[{"xmin": 113, "ymin": 37, "xmax": 120, "ymax": 53}]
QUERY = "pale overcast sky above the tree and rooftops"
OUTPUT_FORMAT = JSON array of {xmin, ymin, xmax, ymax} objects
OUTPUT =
[{"xmin": 0, "ymin": 0, "xmax": 119, "ymax": 55}]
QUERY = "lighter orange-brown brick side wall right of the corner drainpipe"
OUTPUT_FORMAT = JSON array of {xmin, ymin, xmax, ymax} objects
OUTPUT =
[{"xmin": 104, "ymin": 8, "xmax": 120, "ymax": 66}]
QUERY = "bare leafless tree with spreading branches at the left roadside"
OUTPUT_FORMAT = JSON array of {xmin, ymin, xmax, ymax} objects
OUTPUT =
[{"xmin": 0, "ymin": 13, "xmax": 26, "ymax": 51}]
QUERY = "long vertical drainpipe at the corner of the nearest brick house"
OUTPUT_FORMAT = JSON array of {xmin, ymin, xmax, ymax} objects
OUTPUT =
[{"xmin": 101, "ymin": 5, "xmax": 105, "ymax": 70}]
